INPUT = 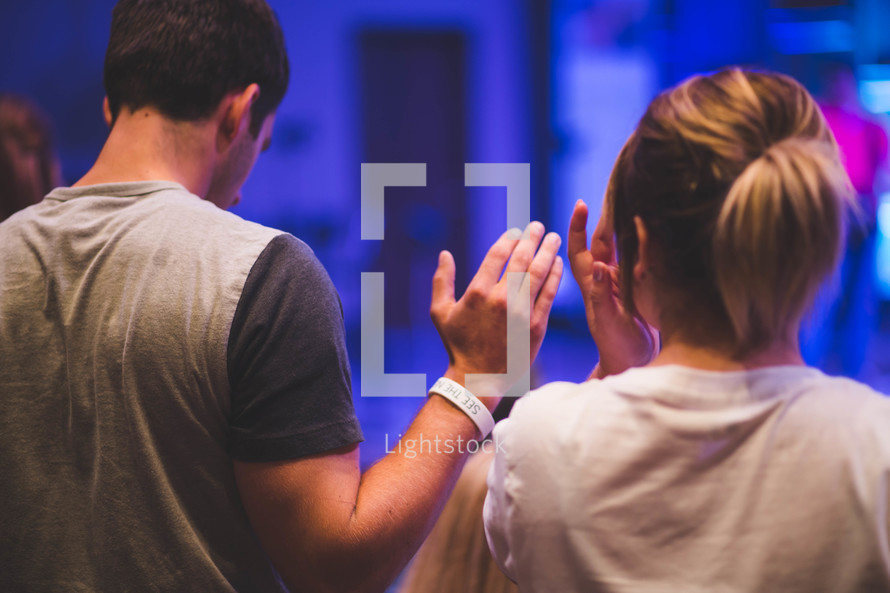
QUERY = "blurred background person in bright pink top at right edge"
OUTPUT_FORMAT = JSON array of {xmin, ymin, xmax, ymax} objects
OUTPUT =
[{"xmin": 802, "ymin": 62, "xmax": 887, "ymax": 378}]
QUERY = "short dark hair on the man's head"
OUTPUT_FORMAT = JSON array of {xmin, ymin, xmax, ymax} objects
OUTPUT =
[{"xmin": 105, "ymin": 0, "xmax": 289, "ymax": 135}]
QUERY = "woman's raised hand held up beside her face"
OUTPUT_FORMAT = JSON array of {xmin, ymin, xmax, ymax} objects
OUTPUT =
[{"xmin": 568, "ymin": 200, "xmax": 658, "ymax": 377}]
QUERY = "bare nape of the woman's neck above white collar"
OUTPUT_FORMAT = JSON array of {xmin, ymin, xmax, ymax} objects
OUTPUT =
[{"xmin": 649, "ymin": 338, "xmax": 806, "ymax": 371}]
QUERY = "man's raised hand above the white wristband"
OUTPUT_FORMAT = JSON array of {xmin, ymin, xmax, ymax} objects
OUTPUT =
[{"xmin": 430, "ymin": 222, "xmax": 563, "ymax": 409}]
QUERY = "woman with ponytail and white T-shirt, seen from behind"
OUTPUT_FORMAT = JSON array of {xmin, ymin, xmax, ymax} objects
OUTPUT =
[{"xmin": 484, "ymin": 69, "xmax": 890, "ymax": 593}]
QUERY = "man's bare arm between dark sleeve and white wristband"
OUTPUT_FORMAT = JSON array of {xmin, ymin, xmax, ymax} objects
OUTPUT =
[{"xmin": 235, "ymin": 388, "xmax": 481, "ymax": 593}]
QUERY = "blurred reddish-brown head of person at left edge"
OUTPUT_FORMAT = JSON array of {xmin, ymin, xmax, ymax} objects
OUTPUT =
[{"xmin": 0, "ymin": 93, "xmax": 62, "ymax": 221}]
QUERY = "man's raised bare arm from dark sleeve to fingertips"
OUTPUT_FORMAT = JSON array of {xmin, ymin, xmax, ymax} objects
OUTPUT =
[{"xmin": 235, "ymin": 222, "xmax": 563, "ymax": 593}]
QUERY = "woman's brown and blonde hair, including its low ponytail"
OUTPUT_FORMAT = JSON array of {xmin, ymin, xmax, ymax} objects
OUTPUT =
[{"xmin": 606, "ymin": 68, "xmax": 853, "ymax": 356}]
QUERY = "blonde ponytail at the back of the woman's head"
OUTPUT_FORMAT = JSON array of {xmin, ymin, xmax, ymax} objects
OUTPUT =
[{"xmin": 713, "ymin": 137, "xmax": 854, "ymax": 352}]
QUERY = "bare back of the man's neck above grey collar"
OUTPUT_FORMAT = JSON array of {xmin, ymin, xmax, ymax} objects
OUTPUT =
[{"xmin": 74, "ymin": 108, "xmax": 216, "ymax": 197}]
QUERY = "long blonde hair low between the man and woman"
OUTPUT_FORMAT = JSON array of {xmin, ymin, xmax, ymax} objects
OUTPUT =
[{"xmin": 399, "ymin": 450, "xmax": 519, "ymax": 593}]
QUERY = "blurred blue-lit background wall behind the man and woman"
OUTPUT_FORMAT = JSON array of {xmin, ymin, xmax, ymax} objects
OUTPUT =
[{"xmin": 0, "ymin": 0, "xmax": 890, "ymax": 472}]
